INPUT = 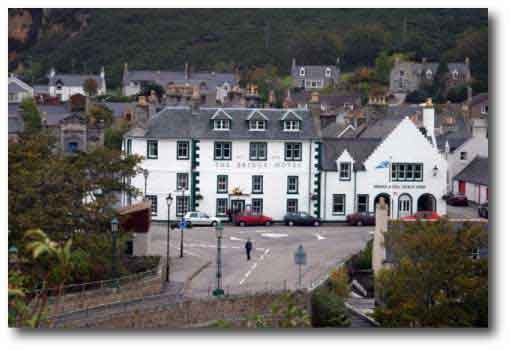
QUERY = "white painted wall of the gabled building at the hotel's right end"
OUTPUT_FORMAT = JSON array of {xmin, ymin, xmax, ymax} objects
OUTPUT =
[{"xmin": 322, "ymin": 118, "xmax": 447, "ymax": 220}]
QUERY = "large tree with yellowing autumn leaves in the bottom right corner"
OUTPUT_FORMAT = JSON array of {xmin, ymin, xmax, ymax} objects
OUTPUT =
[{"xmin": 375, "ymin": 221, "xmax": 489, "ymax": 327}]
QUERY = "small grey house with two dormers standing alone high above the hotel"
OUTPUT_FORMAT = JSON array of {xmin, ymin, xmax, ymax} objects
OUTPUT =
[{"xmin": 290, "ymin": 58, "xmax": 340, "ymax": 90}]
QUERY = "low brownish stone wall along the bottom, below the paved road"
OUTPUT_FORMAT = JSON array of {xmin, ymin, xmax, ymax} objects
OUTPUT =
[{"xmin": 57, "ymin": 292, "xmax": 309, "ymax": 329}]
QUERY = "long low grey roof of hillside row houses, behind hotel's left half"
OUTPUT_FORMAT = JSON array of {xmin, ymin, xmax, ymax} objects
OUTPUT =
[{"xmin": 122, "ymin": 70, "xmax": 237, "ymax": 88}]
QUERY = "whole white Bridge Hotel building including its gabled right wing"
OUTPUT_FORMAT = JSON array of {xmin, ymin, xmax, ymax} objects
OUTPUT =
[{"xmin": 123, "ymin": 102, "xmax": 447, "ymax": 221}]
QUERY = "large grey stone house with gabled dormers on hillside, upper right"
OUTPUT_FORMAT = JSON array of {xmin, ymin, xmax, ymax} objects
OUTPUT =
[{"xmin": 390, "ymin": 58, "xmax": 471, "ymax": 93}]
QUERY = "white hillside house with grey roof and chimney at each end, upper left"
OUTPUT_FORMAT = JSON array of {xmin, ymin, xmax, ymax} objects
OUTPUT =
[{"xmin": 48, "ymin": 68, "xmax": 106, "ymax": 102}]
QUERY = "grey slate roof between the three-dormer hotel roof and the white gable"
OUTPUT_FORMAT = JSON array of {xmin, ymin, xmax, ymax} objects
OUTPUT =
[{"xmin": 321, "ymin": 138, "xmax": 381, "ymax": 171}]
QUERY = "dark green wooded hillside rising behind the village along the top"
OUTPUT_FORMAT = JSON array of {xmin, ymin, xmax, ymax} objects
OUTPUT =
[{"xmin": 9, "ymin": 9, "xmax": 488, "ymax": 87}]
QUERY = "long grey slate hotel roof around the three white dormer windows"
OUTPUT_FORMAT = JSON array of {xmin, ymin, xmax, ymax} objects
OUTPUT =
[{"xmin": 135, "ymin": 107, "xmax": 317, "ymax": 140}]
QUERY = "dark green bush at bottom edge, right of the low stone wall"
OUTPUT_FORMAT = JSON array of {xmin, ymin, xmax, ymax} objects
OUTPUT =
[{"xmin": 311, "ymin": 287, "xmax": 351, "ymax": 327}]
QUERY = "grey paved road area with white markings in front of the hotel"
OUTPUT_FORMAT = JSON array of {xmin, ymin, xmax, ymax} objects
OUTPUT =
[{"xmin": 149, "ymin": 223, "xmax": 374, "ymax": 296}]
